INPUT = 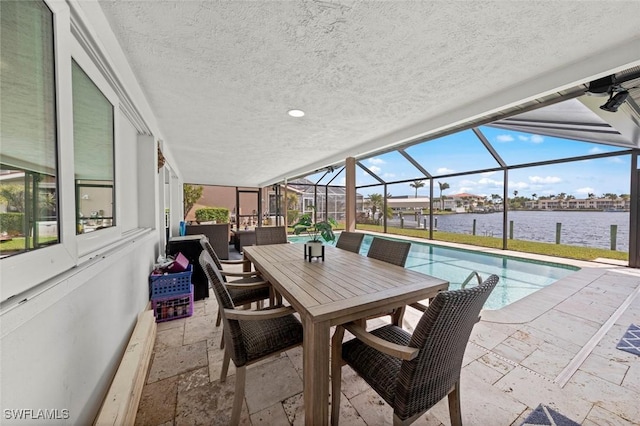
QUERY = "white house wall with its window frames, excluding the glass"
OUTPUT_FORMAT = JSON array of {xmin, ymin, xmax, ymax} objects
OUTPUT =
[{"xmin": 0, "ymin": 0, "xmax": 182, "ymax": 425}]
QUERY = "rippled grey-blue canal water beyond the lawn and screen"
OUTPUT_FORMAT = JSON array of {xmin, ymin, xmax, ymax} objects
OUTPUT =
[{"xmin": 389, "ymin": 211, "xmax": 629, "ymax": 251}]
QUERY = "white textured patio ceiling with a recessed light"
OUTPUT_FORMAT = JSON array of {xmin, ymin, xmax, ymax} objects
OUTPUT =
[{"xmin": 99, "ymin": 0, "xmax": 640, "ymax": 186}]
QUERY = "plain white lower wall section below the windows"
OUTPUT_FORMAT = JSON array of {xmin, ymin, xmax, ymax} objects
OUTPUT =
[{"xmin": 0, "ymin": 231, "xmax": 157, "ymax": 425}]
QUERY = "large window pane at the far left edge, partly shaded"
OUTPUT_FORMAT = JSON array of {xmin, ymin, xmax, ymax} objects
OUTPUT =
[{"xmin": 0, "ymin": 1, "xmax": 60, "ymax": 258}]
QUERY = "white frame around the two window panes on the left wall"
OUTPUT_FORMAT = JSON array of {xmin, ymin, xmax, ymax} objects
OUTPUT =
[{"xmin": 0, "ymin": 0, "xmax": 124, "ymax": 302}]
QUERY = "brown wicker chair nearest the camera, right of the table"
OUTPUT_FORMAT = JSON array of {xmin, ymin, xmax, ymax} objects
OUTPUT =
[{"xmin": 331, "ymin": 275, "xmax": 498, "ymax": 425}]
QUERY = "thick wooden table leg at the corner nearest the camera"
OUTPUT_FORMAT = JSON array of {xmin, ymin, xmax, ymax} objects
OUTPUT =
[{"xmin": 303, "ymin": 319, "xmax": 330, "ymax": 425}]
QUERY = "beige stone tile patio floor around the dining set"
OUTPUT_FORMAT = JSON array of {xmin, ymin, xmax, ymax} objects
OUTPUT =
[{"xmin": 136, "ymin": 255, "xmax": 640, "ymax": 426}]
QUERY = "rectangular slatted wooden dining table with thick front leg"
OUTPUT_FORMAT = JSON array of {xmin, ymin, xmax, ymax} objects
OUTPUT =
[{"xmin": 244, "ymin": 244, "xmax": 449, "ymax": 425}]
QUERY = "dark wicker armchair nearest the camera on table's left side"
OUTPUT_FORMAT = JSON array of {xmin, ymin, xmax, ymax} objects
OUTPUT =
[{"xmin": 199, "ymin": 251, "xmax": 303, "ymax": 425}]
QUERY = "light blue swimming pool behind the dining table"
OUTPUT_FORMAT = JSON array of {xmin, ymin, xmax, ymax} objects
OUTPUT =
[{"xmin": 289, "ymin": 234, "xmax": 580, "ymax": 309}]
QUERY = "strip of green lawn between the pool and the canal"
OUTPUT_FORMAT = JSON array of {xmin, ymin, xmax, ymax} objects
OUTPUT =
[{"xmin": 356, "ymin": 224, "xmax": 629, "ymax": 261}]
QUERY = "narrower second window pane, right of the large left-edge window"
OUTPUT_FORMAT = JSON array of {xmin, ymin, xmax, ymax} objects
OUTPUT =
[{"xmin": 72, "ymin": 61, "xmax": 115, "ymax": 234}]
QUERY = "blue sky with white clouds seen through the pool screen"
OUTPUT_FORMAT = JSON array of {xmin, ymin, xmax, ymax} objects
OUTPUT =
[{"xmin": 311, "ymin": 126, "xmax": 630, "ymax": 198}]
